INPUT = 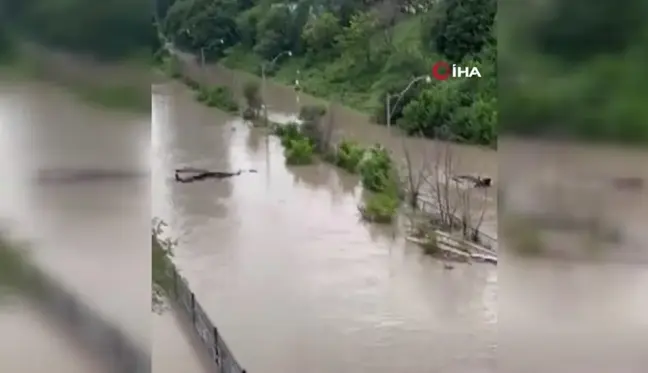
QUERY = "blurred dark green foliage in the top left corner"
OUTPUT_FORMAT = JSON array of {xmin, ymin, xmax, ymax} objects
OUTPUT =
[{"xmin": 0, "ymin": 0, "xmax": 151, "ymax": 61}]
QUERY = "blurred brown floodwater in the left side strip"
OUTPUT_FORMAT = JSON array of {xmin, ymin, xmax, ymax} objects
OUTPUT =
[{"xmin": 0, "ymin": 79, "xmax": 202, "ymax": 373}]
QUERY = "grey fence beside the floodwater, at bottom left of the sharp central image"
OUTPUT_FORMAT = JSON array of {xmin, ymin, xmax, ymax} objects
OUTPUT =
[{"xmin": 167, "ymin": 261, "xmax": 246, "ymax": 373}]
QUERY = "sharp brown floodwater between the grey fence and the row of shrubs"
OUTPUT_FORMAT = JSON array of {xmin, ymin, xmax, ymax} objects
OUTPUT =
[{"xmin": 152, "ymin": 77, "xmax": 497, "ymax": 373}]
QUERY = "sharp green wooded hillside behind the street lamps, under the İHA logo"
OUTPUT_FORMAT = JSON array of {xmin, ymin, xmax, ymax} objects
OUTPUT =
[{"xmin": 162, "ymin": 0, "xmax": 497, "ymax": 145}]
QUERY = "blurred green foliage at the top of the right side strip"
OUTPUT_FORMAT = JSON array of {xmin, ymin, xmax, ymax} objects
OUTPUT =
[{"xmin": 498, "ymin": 0, "xmax": 648, "ymax": 144}]
